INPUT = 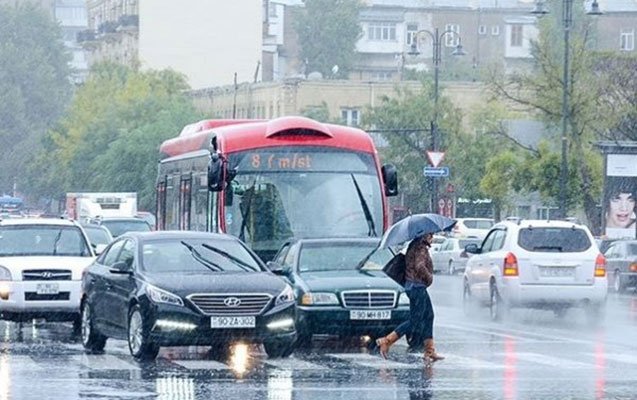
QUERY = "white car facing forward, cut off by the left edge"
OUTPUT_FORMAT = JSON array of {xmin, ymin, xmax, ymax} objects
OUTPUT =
[{"xmin": 0, "ymin": 218, "xmax": 94, "ymax": 326}]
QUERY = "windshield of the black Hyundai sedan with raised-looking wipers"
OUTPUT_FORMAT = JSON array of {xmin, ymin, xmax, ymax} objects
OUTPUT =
[{"xmin": 142, "ymin": 239, "xmax": 262, "ymax": 273}]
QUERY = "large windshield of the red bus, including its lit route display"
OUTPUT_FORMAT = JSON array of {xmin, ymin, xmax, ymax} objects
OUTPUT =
[{"xmin": 224, "ymin": 146, "xmax": 383, "ymax": 254}]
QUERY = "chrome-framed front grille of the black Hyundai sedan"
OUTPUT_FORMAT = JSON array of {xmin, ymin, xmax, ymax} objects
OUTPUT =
[{"xmin": 188, "ymin": 293, "xmax": 272, "ymax": 315}]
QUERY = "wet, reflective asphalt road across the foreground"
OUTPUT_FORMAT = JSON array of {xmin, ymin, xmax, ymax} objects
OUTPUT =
[{"xmin": 0, "ymin": 275, "xmax": 637, "ymax": 400}]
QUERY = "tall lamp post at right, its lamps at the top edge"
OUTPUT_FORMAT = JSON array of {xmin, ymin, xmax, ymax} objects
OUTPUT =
[{"xmin": 531, "ymin": 0, "xmax": 602, "ymax": 218}]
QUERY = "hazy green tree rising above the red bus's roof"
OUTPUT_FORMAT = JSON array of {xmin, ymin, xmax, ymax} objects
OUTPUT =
[{"xmin": 295, "ymin": 0, "xmax": 362, "ymax": 78}]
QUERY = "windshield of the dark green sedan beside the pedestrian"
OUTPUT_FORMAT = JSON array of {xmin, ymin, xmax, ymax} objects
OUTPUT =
[{"xmin": 299, "ymin": 242, "xmax": 392, "ymax": 273}]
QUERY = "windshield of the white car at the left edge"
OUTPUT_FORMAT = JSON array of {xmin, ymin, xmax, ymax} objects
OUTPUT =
[{"xmin": 0, "ymin": 225, "xmax": 91, "ymax": 257}]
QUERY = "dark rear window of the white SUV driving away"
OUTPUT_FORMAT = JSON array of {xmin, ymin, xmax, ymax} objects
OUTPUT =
[{"xmin": 518, "ymin": 227, "xmax": 591, "ymax": 253}]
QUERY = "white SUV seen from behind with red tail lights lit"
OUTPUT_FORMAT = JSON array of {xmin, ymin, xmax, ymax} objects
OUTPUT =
[{"xmin": 463, "ymin": 220, "xmax": 608, "ymax": 321}]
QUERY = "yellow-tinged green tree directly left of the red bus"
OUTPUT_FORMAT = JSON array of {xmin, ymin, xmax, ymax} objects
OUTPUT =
[{"xmin": 31, "ymin": 64, "xmax": 201, "ymax": 209}]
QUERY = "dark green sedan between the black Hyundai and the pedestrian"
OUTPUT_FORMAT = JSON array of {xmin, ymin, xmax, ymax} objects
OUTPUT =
[{"xmin": 268, "ymin": 238, "xmax": 409, "ymax": 347}]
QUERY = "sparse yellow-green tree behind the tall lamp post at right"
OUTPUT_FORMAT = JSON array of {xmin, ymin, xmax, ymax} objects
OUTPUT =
[{"xmin": 489, "ymin": 7, "xmax": 601, "ymax": 227}]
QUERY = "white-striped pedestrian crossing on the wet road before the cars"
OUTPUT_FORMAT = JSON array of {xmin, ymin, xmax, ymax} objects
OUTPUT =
[{"xmin": 6, "ymin": 349, "xmax": 637, "ymax": 374}]
